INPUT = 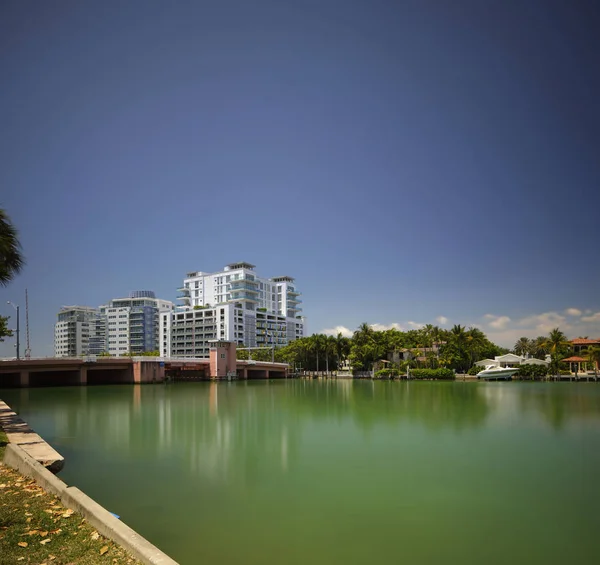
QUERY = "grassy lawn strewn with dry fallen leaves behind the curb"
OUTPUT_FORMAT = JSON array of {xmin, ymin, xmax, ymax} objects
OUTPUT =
[{"xmin": 0, "ymin": 458, "xmax": 140, "ymax": 565}]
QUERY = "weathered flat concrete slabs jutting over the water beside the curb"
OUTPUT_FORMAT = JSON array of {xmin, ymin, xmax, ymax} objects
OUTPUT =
[{"xmin": 0, "ymin": 400, "xmax": 65, "ymax": 473}]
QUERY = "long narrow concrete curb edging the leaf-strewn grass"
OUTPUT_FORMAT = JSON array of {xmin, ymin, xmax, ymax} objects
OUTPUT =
[{"xmin": 4, "ymin": 443, "xmax": 178, "ymax": 565}]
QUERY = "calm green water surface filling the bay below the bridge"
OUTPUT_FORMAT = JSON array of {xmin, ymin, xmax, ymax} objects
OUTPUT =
[{"xmin": 0, "ymin": 380, "xmax": 600, "ymax": 565}]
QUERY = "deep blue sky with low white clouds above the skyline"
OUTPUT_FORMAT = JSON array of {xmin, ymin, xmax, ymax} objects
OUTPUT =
[{"xmin": 0, "ymin": 0, "xmax": 600, "ymax": 356}]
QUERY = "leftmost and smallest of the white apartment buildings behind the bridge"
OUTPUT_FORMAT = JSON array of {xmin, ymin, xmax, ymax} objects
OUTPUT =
[{"xmin": 54, "ymin": 306, "xmax": 105, "ymax": 357}]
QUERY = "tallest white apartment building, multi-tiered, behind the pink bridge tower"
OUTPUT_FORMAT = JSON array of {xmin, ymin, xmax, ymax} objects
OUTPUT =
[{"xmin": 159, "ymin": 262, "xmax": 306, "ymax": 357}]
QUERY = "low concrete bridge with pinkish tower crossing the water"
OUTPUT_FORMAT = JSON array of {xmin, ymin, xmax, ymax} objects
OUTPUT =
[{"xmin": 0, "ymin": 342, "xmax": 288, "ymax": 388}]
